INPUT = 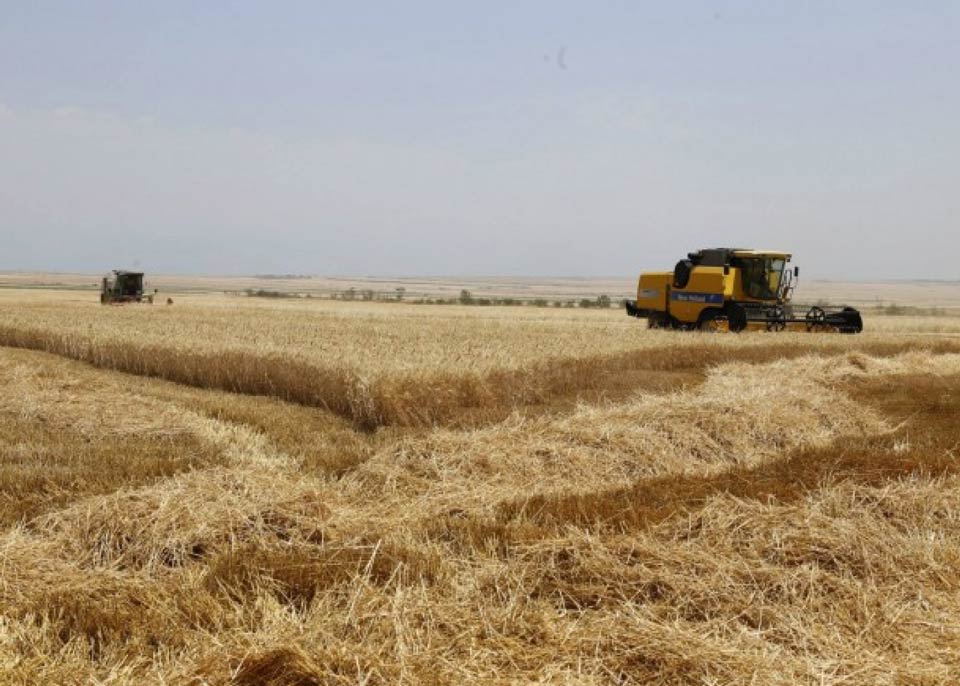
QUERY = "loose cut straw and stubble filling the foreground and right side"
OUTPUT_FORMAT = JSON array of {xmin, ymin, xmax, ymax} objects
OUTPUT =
[{"xmin": 0, "ymin": 344, "xmax": 960, "ymax": 686}]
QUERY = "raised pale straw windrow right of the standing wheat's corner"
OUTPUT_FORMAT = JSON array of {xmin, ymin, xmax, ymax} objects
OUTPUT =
[{"xmin": 342, "ymin": 354, "xmax": 912, "ymax": 536}]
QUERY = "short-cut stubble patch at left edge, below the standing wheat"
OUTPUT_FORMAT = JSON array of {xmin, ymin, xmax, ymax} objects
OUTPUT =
[{"xmin": 0, "ymin": 348, "xmax": 390, "ymax": 523}]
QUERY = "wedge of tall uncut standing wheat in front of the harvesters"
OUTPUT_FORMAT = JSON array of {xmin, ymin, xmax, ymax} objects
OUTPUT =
[{"xmin": 0, "ymin": 296, "xmax": 960, "ymax": 430}]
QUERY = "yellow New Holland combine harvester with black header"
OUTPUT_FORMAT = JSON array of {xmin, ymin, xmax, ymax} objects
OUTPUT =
[{"xmin": 627, "ymin": 248, "xmax": 863, "ymax": 333}]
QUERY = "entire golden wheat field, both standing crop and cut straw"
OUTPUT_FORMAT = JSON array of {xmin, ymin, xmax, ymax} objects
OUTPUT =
[{"xmin": 0, "ymin": 290, "xmax": 960, "ymax": 686}]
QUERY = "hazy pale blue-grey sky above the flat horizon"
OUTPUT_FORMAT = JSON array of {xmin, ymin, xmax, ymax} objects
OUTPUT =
[{"xmin": 0, "ymin": 0, "xmax": 960, "ymax": 279}]
